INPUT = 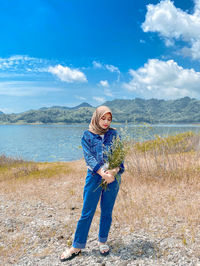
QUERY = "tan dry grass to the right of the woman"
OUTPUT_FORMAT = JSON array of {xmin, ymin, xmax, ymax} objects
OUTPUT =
[{"xmin": 114, "ymin": 133, "xmax": 200, "ymax": 256}]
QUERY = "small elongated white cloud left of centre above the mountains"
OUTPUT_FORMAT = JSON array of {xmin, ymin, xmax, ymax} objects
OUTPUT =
[{"xmin": 48, "ymin": 65, "xmax": 87, "ymax": 83}]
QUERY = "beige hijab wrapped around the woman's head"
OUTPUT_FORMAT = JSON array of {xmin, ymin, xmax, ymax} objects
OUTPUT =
[{"xmin": 89, "ymin": 105, "xmax": 115, "ymax": 135}]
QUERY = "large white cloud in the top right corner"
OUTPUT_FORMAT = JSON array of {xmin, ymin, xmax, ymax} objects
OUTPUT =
[{"xmin": 142, "ymin": 0, "xmax": 200, "ymax": 59}]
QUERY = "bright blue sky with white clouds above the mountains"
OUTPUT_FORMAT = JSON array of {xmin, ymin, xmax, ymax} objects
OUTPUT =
[{"xmin": 0, "ymin": 0, "xmax": 200, "ymax": 113}]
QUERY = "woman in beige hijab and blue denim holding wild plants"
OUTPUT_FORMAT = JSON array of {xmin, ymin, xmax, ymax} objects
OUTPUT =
[{"xmin": 60, "ymin": 106, "xmax": 124, "ymax": 262}]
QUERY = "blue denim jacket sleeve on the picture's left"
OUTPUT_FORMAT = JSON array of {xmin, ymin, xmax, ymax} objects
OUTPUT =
[{"xmin": 81, "ymin": 134, "xmax": 103, "ymax": 173}]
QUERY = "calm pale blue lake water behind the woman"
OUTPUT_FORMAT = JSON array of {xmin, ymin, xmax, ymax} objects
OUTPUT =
[{"xmin": 0, "ymin": 124, "xmax": 200, "ymax": 162}]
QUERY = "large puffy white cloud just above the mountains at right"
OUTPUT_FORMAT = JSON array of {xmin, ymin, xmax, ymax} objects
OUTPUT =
[{"xmin": 123, "ymin": 59, "xmax": 200, "ymax": 99}]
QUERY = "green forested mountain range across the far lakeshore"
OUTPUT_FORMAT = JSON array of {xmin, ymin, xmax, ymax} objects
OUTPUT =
[{"xmin": 0, "ymin": 97, "xmax": 200, "ymax": 124}]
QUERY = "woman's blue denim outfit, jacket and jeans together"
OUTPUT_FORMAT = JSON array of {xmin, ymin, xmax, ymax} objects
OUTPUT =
[{"xmin": 72, "ymin": 128, "xmax": 124, "ymax": 249}]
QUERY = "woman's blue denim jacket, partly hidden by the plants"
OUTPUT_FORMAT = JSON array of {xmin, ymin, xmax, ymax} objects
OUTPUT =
[{"xmin": 81, "ymin": 128, "xmax": 125, "ymax": 174}]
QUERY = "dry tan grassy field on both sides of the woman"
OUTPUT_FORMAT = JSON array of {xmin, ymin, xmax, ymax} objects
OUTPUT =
[{"xmin": 0, "ymin": 132, "xmax": 200, "ymax": 262}]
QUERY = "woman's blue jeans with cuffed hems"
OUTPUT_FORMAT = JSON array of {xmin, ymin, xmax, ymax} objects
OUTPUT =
[{"xmin": 72, "ymin": 169, "xmax": 121, "ymax": 249}]
